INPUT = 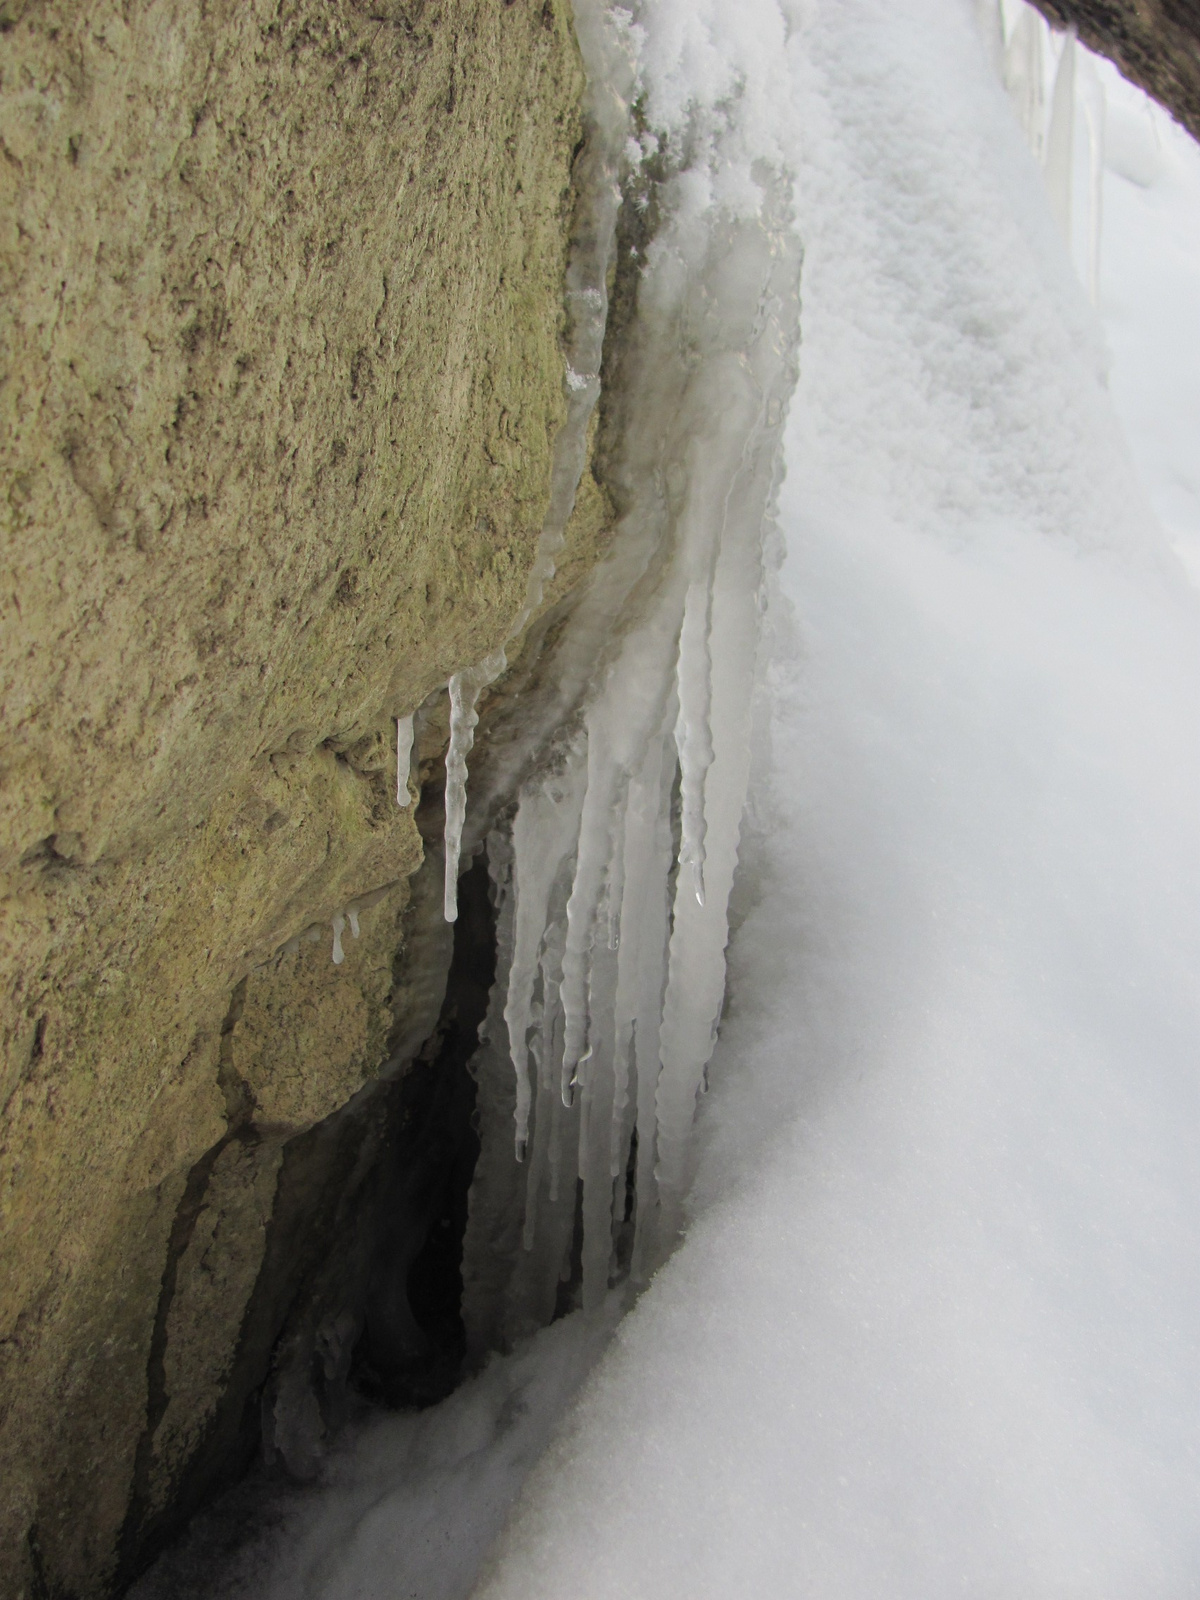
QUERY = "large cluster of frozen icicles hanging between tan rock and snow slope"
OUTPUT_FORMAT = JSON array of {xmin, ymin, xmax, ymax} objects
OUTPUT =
[{"xmin": 446, "ymin": 6, "xmax": 809, "ymax": 1349}]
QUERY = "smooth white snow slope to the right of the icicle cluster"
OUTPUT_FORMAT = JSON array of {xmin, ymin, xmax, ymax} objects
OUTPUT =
[{"xmin": 148, "ymin": 0, "xmax": 1200, "ymax": 1600}]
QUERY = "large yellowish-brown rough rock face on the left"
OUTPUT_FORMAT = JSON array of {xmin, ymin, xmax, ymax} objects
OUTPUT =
[{"xmin": 0, "ymin": 0, "xmax": 598, "ymax": 1600}]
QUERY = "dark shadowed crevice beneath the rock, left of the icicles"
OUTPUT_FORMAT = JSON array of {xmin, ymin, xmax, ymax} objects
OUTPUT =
[{"xmin": 117, "ymin": 844, "xmax": 496, "ymax": 1594}]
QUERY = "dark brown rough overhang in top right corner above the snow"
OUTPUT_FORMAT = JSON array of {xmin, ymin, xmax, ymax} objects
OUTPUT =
[{"xmin": 1034, "ymin": 0, "xmax": 1200, "ymax": 139}]
